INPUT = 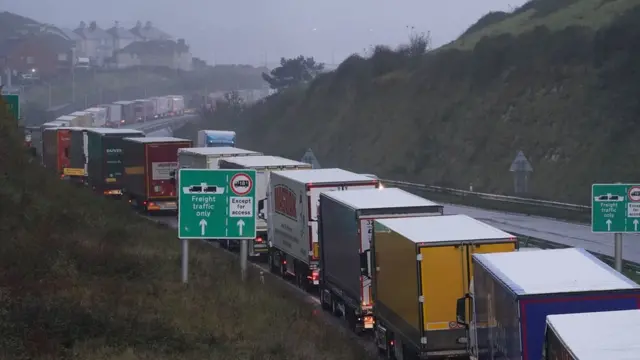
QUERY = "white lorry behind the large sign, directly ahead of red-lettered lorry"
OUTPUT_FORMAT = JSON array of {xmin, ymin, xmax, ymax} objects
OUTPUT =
[{"xmin": 219, "ymin": 155, "xmax": 311, "ymax": 257}]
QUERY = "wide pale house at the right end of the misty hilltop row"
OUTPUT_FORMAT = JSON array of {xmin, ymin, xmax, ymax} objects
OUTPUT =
[{"xmin": 114, "ymin": 39, "xmax": 193, "ymax": 71}]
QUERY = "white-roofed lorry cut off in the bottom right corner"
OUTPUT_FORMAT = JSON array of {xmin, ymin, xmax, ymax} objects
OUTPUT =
[{"xmin": 542, "ymin": 310, "xmax": 640, "ymax": 360}]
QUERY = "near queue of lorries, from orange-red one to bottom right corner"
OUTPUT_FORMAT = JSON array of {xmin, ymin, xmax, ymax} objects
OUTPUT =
[{"xmin": 33, "ymin": 127, "xmax": 640, "ymax": 360}]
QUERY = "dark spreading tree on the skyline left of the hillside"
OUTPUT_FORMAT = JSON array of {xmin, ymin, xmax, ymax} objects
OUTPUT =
[{"xmin": 262, "ymin": 55, "xmax": 324, "ymax": 90}]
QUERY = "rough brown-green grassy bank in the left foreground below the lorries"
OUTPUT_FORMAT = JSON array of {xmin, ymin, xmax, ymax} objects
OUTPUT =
[{"xmin": 0, "ymin": 97, "xmax": 368, "ymax": 360}]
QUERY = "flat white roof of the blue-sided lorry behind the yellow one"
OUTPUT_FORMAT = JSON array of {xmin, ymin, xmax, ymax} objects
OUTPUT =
[{"xmin": 473, "ymin": 248, "xmax": 640, "ymax": 295}]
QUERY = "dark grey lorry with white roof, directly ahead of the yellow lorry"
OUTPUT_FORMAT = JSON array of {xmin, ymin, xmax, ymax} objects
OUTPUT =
[{"xmin": 318, "ymin": 188, "xmax": 444, "ymax": 333}]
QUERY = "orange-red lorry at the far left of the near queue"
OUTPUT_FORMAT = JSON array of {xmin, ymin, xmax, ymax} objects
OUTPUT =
[{"xmin": 42, "ymin": 127, "xmax": 71, "ymax": 178}]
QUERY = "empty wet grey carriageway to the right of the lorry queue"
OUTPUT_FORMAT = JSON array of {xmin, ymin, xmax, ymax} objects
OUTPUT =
[{"xmin": 444, "ymin": 204, "xmax": 640, "ymax": 263}]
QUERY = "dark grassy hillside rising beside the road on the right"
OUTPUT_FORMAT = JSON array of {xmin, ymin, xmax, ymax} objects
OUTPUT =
[{"xmin": 205, "ymin": 0, "xmax": 640, "ymax": 203}]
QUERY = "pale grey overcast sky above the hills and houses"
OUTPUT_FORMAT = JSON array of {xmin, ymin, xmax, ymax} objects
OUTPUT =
[{"xmin": 0, "ymin": 0, "xmax": 525, "ymax": 65}]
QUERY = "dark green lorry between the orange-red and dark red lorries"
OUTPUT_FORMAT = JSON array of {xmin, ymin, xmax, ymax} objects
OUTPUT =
[{"xmin": 87, "ymin": 128, "xmax": 144, "ymax": 197}]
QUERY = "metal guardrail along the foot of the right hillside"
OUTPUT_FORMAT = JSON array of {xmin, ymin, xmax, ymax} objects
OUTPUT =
[{"xmin": 380, "ymin": 179, "xmax": 591, "ymax": 212}]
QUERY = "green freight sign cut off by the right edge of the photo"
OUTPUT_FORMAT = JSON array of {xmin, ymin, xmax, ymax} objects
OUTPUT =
[{"xmin": 591, "ymin": 184, "xmax": 640, "ymax": 233}]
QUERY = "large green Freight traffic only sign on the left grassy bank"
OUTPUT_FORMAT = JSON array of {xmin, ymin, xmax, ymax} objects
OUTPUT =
[{"xmin": 178, "ymin": 169, "xmax": 256, "ymax": 239}]
